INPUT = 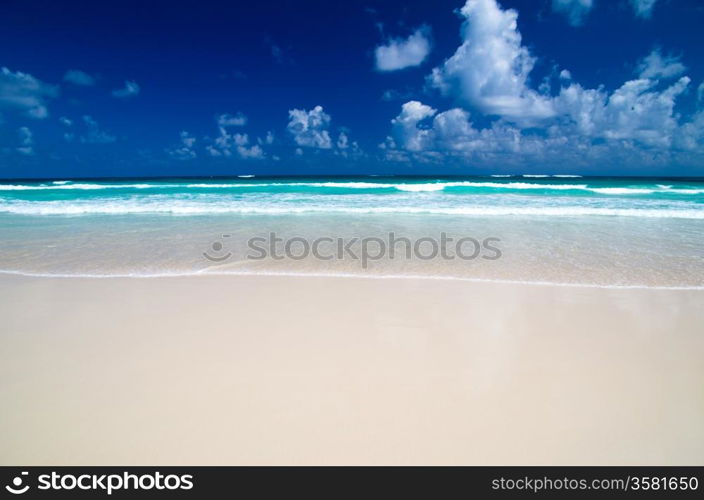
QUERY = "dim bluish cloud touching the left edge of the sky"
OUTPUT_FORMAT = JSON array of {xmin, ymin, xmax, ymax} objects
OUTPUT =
[{"xmin": 0, "ymin": 67, "xmax": 58, "ymax": 118}]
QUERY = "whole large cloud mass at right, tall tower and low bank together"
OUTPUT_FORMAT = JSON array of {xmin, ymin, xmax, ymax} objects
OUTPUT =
[{"xmin": 379, "ymin": 0, "xmax": 704, "ymax": 169}]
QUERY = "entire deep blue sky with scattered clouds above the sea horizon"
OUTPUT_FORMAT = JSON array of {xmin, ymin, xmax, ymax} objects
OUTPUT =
[{"xmin": 0, "ymin": 0, "xmax": 704, "ymax": 178}]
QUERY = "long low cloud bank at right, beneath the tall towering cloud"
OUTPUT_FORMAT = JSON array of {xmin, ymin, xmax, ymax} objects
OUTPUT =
[{"xmin": 390, "ymin": 64, "xmax": 704, "ymax": 167}]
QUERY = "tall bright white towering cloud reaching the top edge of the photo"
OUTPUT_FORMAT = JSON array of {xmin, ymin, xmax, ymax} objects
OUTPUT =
[{"xmin": 429, "ymin": 0, "xmax": 555, "ymax": 123}]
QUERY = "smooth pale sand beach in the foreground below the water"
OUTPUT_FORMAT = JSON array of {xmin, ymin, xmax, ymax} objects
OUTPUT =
[{"xmin": 0, "ymin": 275, "xmax": 704, "ymax": 465}]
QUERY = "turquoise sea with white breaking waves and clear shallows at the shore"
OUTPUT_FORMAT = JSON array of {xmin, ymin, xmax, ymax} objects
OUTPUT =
[{"xmin": 0, "ymin": 175, "xmax": 704, "ymax": 287}]
